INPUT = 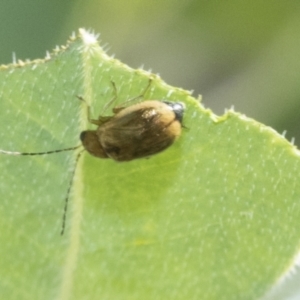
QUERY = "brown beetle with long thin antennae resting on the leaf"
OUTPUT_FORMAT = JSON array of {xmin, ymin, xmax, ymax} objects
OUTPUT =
[{"xmin": 0, "ymin": 79, "xmax": 185, "ymax": 235}]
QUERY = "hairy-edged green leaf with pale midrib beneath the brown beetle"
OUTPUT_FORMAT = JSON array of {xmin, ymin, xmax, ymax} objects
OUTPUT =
[{"xmin": 0, "ymin": 30, "xmax": 300, "ymax": 300}]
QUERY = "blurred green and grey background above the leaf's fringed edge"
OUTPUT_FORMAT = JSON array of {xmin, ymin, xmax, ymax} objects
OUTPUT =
[{"xmin": 0, "ymin": 0, "xmax": 300, "ymax": 145}]
